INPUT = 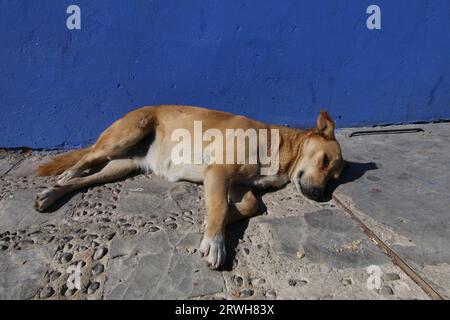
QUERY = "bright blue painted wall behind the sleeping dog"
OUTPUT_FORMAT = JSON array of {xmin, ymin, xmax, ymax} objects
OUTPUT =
[{"xmin": 0, "ymin": 0, "xmax": 450, "ymax": 147}]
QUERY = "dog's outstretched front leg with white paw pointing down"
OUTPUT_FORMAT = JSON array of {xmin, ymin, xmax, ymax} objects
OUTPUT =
[{"xmin": 200, "ymin": 166, "xmax": 229, "ymax": 269}]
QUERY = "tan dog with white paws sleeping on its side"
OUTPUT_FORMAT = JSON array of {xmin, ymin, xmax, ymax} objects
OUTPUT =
[{"xmin": 34, "ymin": 105, "xmax": 344, "ymax": 268}]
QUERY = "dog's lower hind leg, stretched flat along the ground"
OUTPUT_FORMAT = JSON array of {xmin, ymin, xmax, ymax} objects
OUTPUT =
[{"xmin": 34, "ymin": 159, "xmax": 138, "ymax": 212}]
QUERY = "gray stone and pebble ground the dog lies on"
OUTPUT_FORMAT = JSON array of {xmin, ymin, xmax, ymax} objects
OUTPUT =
[{"xmin": 0, "ymin": 124, "xmax": 450, "ymax": 299}]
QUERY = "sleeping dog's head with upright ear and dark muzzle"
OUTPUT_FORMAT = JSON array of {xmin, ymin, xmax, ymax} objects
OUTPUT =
[{"xmin": 290, "ymin": 111, "xmax": 345, "ymax": 200}]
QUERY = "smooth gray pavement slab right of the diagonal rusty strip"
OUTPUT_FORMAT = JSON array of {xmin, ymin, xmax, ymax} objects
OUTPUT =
[{"xmin": 334, "ymin": 123, "xmax": 450, "ymax": 299}]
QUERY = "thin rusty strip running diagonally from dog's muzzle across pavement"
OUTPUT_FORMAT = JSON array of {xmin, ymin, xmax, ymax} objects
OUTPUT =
[{"xmin": 332, "ymin": 195, "xmax": 444, "ymax": 300}]
